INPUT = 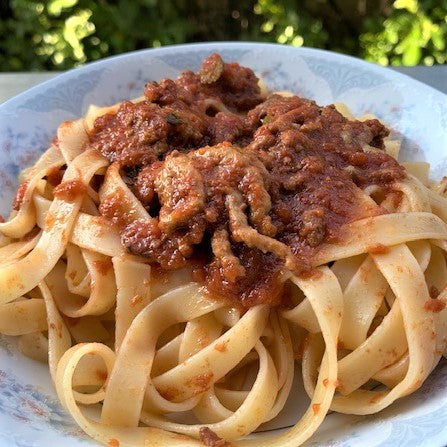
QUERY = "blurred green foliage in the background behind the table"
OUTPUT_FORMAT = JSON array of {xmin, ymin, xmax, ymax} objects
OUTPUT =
[{"xmin": 0, "ymin": 0, "xmax": 447, "ymax": 71}]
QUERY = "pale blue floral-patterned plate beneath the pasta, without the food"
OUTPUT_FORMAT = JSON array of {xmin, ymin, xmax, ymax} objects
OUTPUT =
[{"xmin": 0, "ymin": 43, "xmax": 447, "ymax": 447}]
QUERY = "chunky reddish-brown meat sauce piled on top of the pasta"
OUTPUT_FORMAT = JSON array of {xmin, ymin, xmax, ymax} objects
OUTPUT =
[{"xmin": 90, "ymin": 54, "xmax": 405, "ymax": 307}]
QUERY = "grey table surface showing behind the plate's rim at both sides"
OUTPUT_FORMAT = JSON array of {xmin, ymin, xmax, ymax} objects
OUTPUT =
[{"xmin": 0, "ymin": 65, "xmax": 447, "ymax": 104}]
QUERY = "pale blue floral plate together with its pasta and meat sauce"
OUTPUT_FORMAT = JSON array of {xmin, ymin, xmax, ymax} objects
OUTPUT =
[{"xmin": 0, "ymin": 43, "xmax": 447, "ymax": 447}]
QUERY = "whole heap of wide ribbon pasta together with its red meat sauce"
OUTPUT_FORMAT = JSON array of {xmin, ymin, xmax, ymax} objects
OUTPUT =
[{"xmin": 0, "ymin": 54, "xmax": 447, "ymax": 447}]
